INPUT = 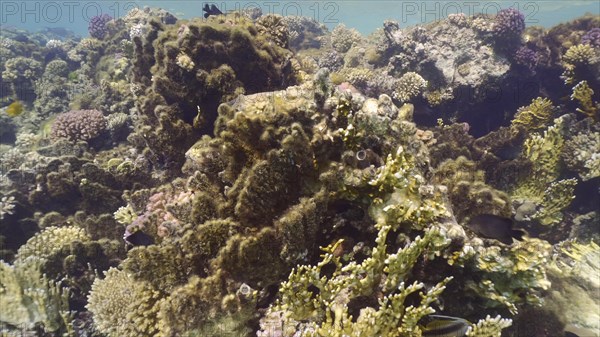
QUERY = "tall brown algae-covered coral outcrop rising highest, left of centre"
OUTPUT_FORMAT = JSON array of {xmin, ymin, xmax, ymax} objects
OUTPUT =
[{"xmin": 131, "ymin": 14, "xmax": 295, "ymax": 173}]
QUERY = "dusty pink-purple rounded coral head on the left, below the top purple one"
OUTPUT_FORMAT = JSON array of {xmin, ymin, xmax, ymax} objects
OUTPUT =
[{"xmin": 50, "ymin": 110, "xmax": 106, "ymax": 141}]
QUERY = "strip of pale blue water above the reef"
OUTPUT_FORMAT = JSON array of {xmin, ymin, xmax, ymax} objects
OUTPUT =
[{"xmin": 0, "ymin": 0, "xmax": 600, "ymax": 36}]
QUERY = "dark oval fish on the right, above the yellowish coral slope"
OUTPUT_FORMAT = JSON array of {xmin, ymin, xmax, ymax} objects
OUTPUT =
[{"xmin": 467, "ymin": 214, "xmax": 526, "ymax": 245}]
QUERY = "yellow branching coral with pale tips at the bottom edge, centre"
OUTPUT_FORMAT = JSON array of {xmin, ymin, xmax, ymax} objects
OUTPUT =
[{"xmin": 270, "ymin": 225, "xmax": 451, "ymax": 337}]
